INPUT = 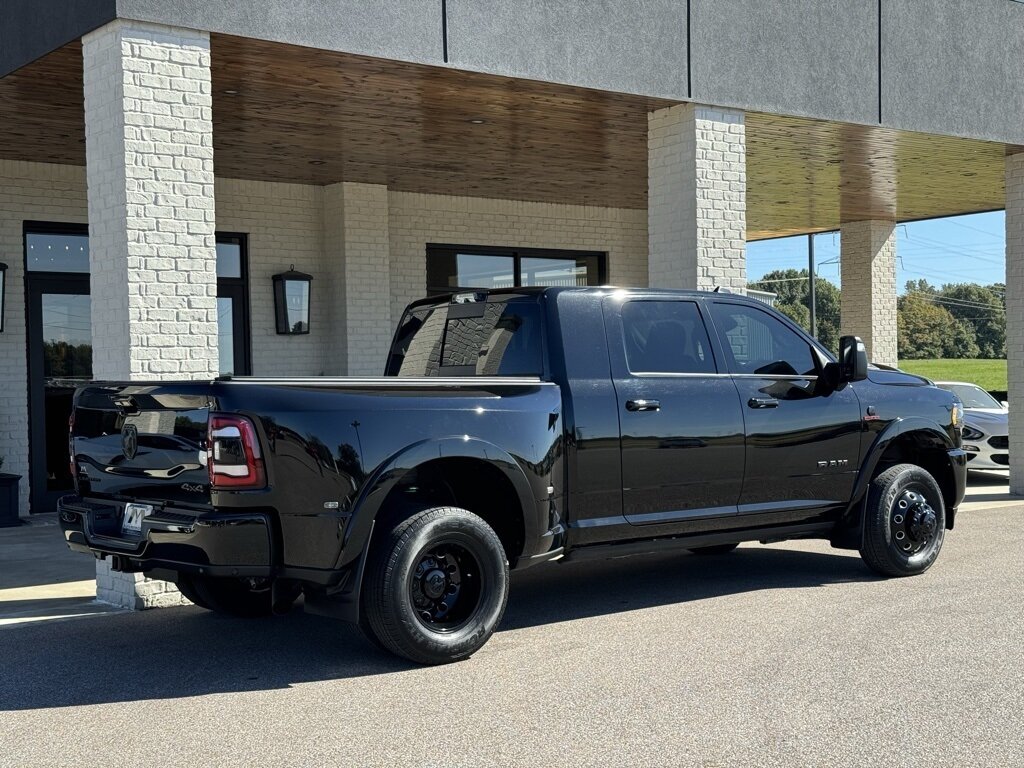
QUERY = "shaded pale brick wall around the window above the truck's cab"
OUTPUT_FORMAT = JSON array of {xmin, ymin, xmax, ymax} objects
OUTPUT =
[{"xmin": 381, "ymin": 190, "xmax": 647, "ymax": 331}]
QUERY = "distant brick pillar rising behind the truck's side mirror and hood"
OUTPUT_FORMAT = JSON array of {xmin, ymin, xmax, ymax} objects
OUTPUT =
[{"xmin": 840, "ymin": 221, "xmax": 897, "ymax": 366}]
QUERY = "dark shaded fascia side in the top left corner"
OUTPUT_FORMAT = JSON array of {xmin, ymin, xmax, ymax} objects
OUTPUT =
[{"xmin": 0, "ymin": 0, "xmax": 117, "ymax": 77}]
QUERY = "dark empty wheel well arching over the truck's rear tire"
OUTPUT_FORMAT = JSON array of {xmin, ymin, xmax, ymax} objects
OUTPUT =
[{"xmin": 381, "ymin": 458, "xmax": 525, "ymax": 565}]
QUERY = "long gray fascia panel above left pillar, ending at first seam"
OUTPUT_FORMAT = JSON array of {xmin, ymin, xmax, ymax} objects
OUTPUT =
[{"xmin": 117, "ymin": 0, "xmax": 443, "ymax": 63}]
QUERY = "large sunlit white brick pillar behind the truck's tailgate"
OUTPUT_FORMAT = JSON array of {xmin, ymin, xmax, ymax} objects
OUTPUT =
[{"xmin": 82, "ymin": 20, "xmax": 218, "ymax": 608}]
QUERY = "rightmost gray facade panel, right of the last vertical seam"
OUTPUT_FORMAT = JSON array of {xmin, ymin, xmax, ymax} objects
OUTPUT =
[{"xmin": 882, "ymin": 0, "xmax": 1024, "ymax": 143}]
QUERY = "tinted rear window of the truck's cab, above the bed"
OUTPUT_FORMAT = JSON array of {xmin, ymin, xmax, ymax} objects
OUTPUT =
[{"xmin": 387, "ymin": 297, "xmax": 544, "ymax": 377}]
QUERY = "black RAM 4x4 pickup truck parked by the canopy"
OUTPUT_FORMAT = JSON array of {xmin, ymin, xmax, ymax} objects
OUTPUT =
[{"xmin": 59, "ymin": 288, "xmax": 967, "ymax": 664}]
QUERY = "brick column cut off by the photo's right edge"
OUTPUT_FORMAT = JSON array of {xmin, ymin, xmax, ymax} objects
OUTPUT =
[{"xmin": 1007, "ymin": 155, "xmax": 1024, "ymax": 495}]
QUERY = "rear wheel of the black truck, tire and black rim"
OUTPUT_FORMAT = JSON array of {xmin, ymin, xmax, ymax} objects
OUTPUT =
[{"xmin": 362, "ymin": 507, "xmax": 509, "ymax": 665}]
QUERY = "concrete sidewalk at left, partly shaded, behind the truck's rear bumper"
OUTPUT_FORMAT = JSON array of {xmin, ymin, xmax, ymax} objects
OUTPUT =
[{"xmin": 0, "ymin": 514, "xmax": 120, "ymax": 627}]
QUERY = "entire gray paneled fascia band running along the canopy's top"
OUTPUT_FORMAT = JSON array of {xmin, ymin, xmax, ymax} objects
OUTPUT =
[{"xmin": 6, "ymin": 0, "xmax": 1024, "ymax": 144}]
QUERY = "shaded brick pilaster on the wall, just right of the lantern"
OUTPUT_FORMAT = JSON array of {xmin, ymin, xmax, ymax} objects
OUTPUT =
[{"xmin": 324, "ymin": 181, "xmax": 394, "ymax": 376}]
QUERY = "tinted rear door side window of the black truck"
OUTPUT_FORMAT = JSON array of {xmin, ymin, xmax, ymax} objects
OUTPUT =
[{"xmin": 623, "ymin": 301, "xmax": 716, "ymax": 374}]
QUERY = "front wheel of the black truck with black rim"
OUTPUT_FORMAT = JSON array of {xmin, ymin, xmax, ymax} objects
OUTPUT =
[{"xmin": 860, "ymin": 464, "xmax": 946, "ymax": 577}]
